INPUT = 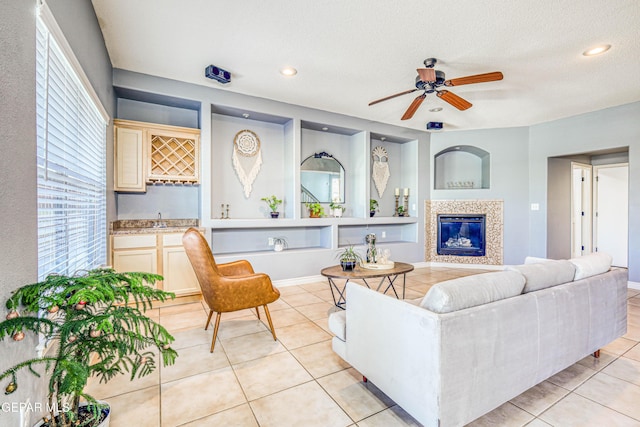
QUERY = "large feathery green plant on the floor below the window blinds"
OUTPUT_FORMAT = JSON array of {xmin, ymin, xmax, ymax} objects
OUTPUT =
[{"xmin": 0, "ymin": 268, "xmax": 177, "ymax": 427}]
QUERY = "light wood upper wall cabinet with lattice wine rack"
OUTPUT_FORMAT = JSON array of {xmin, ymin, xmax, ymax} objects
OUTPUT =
[{"xmin": 114, "ymin": 119, "xmax": 200, "ymax": 192}]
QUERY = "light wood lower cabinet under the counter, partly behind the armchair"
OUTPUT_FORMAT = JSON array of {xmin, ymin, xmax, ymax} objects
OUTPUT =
[{"xmin": 112, "ymin": 233, "xmax": 200, "ymax": 296}]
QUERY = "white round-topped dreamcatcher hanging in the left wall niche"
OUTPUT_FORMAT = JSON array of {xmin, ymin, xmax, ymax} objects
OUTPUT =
[{"xmin": 232, "ymin": 129, "xmax": 262, "ymax": 199}]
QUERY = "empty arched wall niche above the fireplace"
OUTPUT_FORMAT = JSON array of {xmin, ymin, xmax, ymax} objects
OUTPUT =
[{"xmin": 433, "ymin": 145, "xmax": 491, "ymax": 190}]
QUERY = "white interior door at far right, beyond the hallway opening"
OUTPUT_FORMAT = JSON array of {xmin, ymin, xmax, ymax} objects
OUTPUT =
[{"xmin": 594, "ymin": 163, "xmax": 629, "ymax": 267}]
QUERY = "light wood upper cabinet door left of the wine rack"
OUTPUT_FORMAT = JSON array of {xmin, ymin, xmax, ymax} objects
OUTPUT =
[{"xmin": 114, "ymin": 126, "xmax": 146, "ymax": 192}]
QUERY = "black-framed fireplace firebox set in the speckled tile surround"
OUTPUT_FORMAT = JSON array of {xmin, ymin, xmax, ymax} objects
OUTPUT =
[{"xmin": 437, "ymin": 214, "xmax": 486, "ymax": 256}]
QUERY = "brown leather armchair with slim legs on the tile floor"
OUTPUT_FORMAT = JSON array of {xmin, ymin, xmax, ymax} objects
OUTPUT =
[{"xmin": 182, "ymin": 228, "xmax": 280, "ymax": 353}]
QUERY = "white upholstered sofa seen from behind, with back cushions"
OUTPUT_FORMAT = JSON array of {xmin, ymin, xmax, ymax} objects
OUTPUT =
[{"xmin": 329, "ymin": 255, "xmax": 627, "ymax": 427}]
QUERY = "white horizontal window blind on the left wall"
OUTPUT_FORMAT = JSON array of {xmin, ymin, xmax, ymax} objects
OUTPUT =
[{"xmin": 36, "ymin": 17, "xmax": 107, "ymax": 280}]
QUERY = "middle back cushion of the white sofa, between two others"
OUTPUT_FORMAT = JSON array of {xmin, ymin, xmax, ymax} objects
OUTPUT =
[{"xmin": 506, "ymin": 260, "xmax": 576, "ymax": 294}]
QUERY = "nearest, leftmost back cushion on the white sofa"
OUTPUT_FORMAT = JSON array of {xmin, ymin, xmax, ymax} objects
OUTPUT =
[{"xmin": 420, "ymin": 271, "xmax": 524, "ymax": 313}]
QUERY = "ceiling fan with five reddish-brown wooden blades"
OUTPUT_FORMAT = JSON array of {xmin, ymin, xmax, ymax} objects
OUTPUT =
[{"xmin": 369, "ymin": 58, "xmax": 503, "ymax": 120}]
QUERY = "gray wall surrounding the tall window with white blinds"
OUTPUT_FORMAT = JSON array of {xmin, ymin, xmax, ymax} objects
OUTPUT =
[{"xmin": 0, "ymin": 0, "xmax": 115, "ymax": 426}]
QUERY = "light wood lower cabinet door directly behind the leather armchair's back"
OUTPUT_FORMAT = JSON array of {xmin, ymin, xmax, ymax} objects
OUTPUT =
[{"xmin": 162, "ymin": 246, "xmax": 200, "ymax": 295}]
